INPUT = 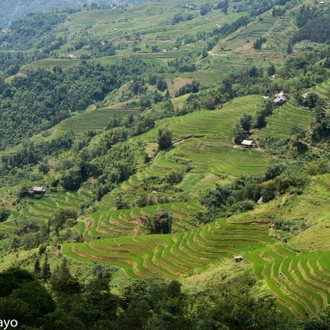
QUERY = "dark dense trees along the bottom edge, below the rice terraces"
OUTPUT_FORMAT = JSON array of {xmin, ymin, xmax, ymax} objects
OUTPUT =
[{"xmin": 0, "ymin": 266, "xmax": 329, "ymax": 330}]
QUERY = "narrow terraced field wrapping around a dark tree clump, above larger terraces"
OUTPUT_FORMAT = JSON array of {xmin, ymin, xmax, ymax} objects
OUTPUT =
[{"xmin": 82, "ymin": 201, "xmax": 203, "ymax": 240}]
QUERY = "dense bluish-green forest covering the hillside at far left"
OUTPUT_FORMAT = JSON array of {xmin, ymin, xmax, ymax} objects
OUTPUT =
[{"xmin": 0, "ymin": 58, "xmax": 148, "ymax": 145}]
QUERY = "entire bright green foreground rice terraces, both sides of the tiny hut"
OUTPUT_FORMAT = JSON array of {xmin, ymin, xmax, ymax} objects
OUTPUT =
[{"xmin": 63, "ymin": 214, "xmax": 330, "ymax": 318}]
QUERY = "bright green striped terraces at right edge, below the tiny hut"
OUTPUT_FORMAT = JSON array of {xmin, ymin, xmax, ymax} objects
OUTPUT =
[{"xmin": 246, "ymin": 244, "xmax": 330, "ymax": 318}]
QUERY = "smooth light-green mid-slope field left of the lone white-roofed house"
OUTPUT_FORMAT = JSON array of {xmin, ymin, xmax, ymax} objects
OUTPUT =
[{"xmin": 133, "ymin": 96, "xmax": 270, "ymax": 181}]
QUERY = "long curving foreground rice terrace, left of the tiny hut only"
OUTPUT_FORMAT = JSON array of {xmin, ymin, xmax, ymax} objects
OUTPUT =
[{"xmin": 63, "ymin": 219, "xmax": 273, "ymax": 279}]
